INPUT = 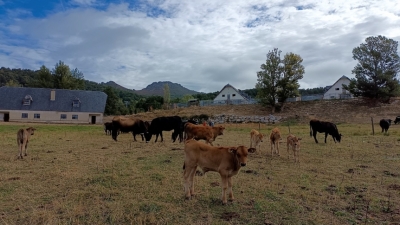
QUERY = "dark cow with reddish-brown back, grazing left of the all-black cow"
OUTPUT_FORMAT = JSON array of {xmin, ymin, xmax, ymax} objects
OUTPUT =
[{"xmin": 111, "ymin": 116, "xmax": 149, "ymax": 141}]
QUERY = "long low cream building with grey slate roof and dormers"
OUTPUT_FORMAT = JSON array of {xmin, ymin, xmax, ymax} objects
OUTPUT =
[{"xmin": 0, "ymin": 87, "xmax": 107, "ymax": 124}]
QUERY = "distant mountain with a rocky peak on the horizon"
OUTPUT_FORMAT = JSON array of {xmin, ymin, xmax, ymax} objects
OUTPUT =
[{"xmin": 135, "ymin": 81, "xmax": 200, "ymax": 98}]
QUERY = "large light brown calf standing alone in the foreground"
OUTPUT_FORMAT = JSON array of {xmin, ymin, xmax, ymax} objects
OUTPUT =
[{"xmin": 183, "ymin": 139, "xmax": 255, "ymax": 204}]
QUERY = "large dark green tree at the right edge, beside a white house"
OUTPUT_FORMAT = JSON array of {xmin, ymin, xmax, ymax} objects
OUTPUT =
[{"xmin": 343, "ymin": 35, "xmax": 400, "ymax": 101}]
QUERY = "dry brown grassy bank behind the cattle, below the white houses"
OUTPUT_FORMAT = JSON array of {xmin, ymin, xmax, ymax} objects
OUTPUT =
[{"xmin": 105, "ymin": 98, "xmax": 400, "ymax": 125}]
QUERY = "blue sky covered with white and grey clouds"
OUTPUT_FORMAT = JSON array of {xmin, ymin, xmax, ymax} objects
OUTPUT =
[{"xmin": 0, "ymin": 0, "xmax": 400, "ymax": 93}]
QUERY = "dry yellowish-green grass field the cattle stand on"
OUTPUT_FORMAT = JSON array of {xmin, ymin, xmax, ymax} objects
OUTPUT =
[{"xmin": 0, "ymin": 123, "xmax": 400, "ymax": 225}]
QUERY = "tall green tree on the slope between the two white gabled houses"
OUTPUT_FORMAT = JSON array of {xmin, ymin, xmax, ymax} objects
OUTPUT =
[{"xmin": 256, "ymin": 48, "xmax": 304, "ymax": 112}]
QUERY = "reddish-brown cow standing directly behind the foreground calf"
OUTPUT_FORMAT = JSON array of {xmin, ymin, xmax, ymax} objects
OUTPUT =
[{"xmin": 185, "ymin": 123, "xmax": 225, "ymax": 145}]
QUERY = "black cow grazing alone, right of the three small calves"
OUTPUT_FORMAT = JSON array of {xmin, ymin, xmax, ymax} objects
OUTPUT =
[{"xmin": 310, "ymin": 119, "xmax": 342, "ymax": 143}]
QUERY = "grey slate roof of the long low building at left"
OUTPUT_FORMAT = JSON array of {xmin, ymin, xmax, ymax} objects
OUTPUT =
[{"xmin": 0, "ymin": 86, "xmax": 107, "ymax": 113}]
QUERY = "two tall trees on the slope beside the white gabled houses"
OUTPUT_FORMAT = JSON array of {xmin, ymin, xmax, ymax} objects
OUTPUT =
[{"xmin": 256, "ymin": 36, "xmax": 400, "ymax": 111}]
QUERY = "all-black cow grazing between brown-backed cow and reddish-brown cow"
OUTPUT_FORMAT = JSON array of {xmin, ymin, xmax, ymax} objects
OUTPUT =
[{"xmin": 144, "ymin": 116, "xmax": 183, "ymax": 143}]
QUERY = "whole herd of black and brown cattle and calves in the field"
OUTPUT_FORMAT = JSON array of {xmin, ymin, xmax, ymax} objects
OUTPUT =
[{"xmin": 17, "ymin": 116, "xmax": 400, "ymax": 204}]
